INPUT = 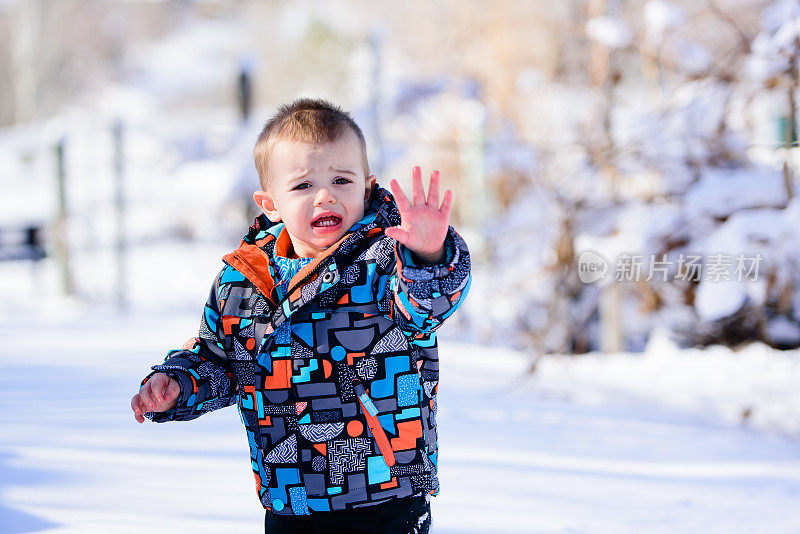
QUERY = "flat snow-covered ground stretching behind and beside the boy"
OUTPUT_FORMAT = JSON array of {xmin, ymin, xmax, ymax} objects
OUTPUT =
[{"xmin": 0, "ymin": 308, "xmax": 800, "ymax": 534}]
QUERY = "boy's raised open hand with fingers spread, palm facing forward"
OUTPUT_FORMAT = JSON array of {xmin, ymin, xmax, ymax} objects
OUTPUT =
[{"xmin": 385, "ymin": 167, "xmax": 453, "ymax": 263}]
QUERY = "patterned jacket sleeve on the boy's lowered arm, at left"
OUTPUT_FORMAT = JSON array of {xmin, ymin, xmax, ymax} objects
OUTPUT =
[{"xmin": 139, "ymin": 270, "xmax": 236, "ymax": 423}]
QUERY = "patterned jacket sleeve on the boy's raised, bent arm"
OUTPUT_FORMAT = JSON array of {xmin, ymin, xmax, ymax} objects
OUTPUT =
[{"xmin": 381, "ymin": 226, "xmax": 471, "ymax": 335}]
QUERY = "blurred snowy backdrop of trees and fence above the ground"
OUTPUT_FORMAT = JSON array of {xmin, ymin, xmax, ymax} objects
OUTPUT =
[{"xmin": 0, "ymin": 0, "xmax": 800, "ymax": 353}]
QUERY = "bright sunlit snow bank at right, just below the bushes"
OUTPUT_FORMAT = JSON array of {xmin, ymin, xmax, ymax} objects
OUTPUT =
[{"xmin": 525, "ymin": 329, "xmax": 800, "ymax": 440}]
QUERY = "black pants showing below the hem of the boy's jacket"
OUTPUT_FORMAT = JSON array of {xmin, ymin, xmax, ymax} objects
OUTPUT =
[{"xmin": 264, "ymin": 496, "xmax": 431, "ymax": 534}]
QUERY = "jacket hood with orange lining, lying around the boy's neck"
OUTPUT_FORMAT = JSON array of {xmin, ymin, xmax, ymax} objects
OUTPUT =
[{"xmin": 222, "ymin": 184, "xmax": 400, "ymax": 305}]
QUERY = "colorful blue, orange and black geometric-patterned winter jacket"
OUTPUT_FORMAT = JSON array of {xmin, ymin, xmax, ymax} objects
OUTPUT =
[{"xmin": 142, "ymin": 187, "xmax": 470, "ymax": 515}]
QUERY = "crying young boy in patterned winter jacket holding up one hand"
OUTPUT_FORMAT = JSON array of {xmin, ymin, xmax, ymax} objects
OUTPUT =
[{"xmin": 131, "ymin": 99, "xmax": 470, "ymax": 534}]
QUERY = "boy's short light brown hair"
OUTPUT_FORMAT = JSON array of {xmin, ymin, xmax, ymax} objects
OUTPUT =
[{"xmin": 253, "ymin": 98, "xmax": 369, "ymax": 191}]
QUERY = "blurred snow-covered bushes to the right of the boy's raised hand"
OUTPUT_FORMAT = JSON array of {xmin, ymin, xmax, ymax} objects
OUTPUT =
[{"xmin": 462, "ymin": 0, "xmax": 800, "ymax": 353}]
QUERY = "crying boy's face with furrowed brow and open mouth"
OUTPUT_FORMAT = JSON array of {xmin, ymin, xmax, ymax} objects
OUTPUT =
[{"xmin": 253, "ymin": 132, "xmax": 375, "ymax": 258}]
